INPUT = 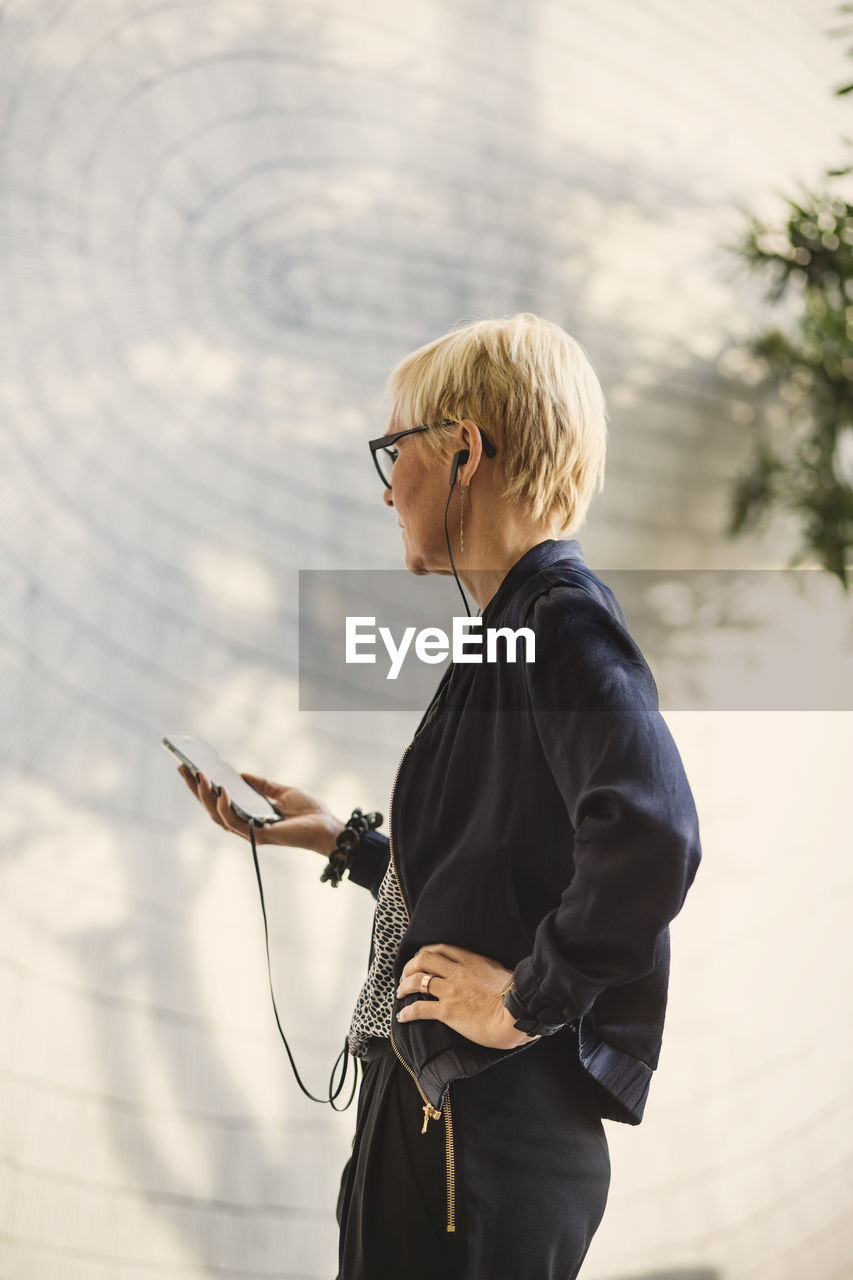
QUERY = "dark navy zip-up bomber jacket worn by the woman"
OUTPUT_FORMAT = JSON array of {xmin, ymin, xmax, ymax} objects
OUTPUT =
[{"xmin": 350, "ymin": 539, "xmax": 701, "ymax": 1124}]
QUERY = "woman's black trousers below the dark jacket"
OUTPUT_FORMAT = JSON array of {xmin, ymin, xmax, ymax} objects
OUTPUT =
[{"xmin": 337, "ymin": 1029, "xmax": 610, "ymax": 1280}]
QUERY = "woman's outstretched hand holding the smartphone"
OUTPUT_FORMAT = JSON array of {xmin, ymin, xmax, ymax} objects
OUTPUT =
[{"xmin": 178, "ymin": 764, "xmax": 345, "ymax": 858}]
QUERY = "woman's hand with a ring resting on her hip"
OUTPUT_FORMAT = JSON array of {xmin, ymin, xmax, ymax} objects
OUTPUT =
[{"xmin": 397, "ymin": 942, "xmax": 539, "ymax": 1048}]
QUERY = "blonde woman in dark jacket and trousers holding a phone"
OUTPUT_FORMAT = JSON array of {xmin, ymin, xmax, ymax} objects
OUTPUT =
[{"xmin": 182, "ymin": 314, "xmax": 701, "ymax": 1280}]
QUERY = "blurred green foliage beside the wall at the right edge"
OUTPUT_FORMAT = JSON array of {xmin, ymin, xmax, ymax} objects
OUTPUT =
[{"xmin": 727, "ymin": 4, "xmax": 853, "ymax": 590}]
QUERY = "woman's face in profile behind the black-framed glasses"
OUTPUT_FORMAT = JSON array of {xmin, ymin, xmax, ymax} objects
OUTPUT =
[{"xmin": 383, "ymin": 426, "xmax": 451, "ymax": 573}]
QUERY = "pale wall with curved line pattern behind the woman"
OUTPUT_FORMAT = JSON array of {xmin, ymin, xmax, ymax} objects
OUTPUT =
[{"xmin": 0, "ymin": 0, "xmax": 853, "ymax": 1280}]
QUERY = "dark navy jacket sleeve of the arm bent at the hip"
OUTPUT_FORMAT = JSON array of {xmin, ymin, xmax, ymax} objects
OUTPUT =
[{"xmin": 514, "ymin": 585, "xmax": 701, "ymax": 1025}]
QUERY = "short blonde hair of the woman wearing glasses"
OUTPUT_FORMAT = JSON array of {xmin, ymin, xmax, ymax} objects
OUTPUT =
[{"xmin": 386, "ymin": 311, "xmax": 607, "ymax": 535}]
